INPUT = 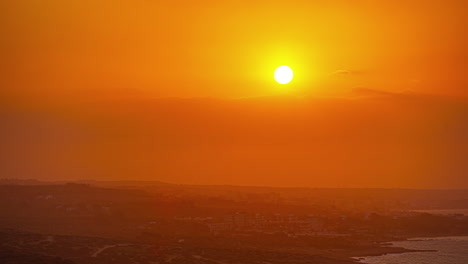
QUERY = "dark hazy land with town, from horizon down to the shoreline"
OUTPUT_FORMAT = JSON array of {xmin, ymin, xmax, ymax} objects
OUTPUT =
[{"xmin": 0, "ymin": 182, "xmax": 468, "ymax": 264}]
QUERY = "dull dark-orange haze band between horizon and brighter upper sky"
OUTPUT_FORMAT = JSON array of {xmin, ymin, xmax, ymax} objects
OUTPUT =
[{"xmin": 0, "ymin": 90, "xmax": 468, "ymax": 188}]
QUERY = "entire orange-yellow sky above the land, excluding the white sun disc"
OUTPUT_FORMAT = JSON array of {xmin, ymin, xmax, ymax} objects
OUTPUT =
[{"xmin": 0, "ymin": 0, "xmax": 468, "ymax": 188}]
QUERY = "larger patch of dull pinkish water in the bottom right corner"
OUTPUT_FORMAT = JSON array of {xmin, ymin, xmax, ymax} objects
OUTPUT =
[{"xmin": 361, "ymin": 236, "xmax": 468, "ymax": 264}]
